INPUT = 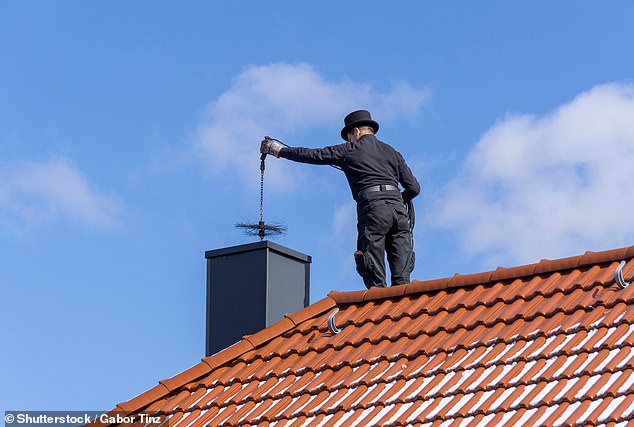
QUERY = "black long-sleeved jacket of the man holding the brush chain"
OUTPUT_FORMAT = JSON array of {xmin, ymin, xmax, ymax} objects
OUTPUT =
[{"xmin": 280, "ymin": 135, "xmax": 420, "ymax": 202}]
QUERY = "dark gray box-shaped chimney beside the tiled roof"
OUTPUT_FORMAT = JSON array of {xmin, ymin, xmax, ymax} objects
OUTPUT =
[{"xmin": 205, "ymin": 240, "xmax": 311, "ymax": 356}]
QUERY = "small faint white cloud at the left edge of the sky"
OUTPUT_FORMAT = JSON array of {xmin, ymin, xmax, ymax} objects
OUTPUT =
[{"xmin": 0, "ymin": 157, "xmax": 121, "ymax": 231}]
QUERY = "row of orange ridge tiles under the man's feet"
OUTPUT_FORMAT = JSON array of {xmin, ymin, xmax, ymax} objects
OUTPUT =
[{"xmin": 328, "ymin": 246, "xmax": 634, "ymax": 304}]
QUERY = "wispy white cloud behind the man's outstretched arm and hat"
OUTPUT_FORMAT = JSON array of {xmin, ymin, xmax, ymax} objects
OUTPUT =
[{"xmin": 196, "ymin": 63, "xmax": 429, "ymax": 190}]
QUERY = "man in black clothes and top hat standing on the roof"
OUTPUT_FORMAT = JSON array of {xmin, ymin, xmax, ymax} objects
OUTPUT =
[{"xmin": 260, "ymin": 110, "xmax": 420, "ymax": 289}]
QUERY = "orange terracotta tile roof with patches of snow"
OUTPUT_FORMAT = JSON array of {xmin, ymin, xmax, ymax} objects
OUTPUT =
[{"xmin": 101, "ymin": 246, "xmax": 634, "ymax": 427}]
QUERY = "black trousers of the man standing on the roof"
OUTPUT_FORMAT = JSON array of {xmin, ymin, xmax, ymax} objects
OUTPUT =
[{"xmin": 355, "ymin": 200, "xmax": 415, "ymax": 289}]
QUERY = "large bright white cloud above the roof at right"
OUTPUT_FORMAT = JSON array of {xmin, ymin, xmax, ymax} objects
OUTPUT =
[{"xmin": 435, "ymin": 83, "xmax": 634, "ymax": 263}]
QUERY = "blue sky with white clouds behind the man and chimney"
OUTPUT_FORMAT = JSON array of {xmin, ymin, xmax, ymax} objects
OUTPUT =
[{"xmin": 0, "ymin": 1, "xmax": 634, "ymax": 410}]
